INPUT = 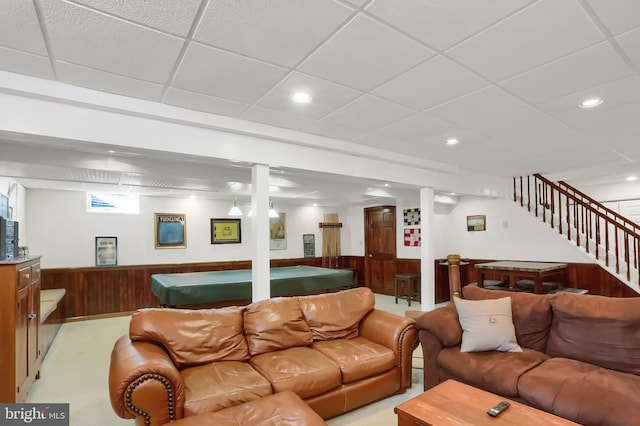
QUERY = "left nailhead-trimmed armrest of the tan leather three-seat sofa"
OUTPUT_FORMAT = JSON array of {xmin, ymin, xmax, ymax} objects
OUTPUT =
[{"xmin": 109, "ymin": 336, "xmax": 185, "ymax": 426}]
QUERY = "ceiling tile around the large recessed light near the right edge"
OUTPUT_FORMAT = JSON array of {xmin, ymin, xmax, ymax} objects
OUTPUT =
[{"xmin": 537, "ymin": 76, "xmax": 640, "ymax": 121}]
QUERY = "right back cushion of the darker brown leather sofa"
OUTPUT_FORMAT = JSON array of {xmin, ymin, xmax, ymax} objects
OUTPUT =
[{"xmin": 547, "ymin": 293, "xmax": 640, "ymax": 375}]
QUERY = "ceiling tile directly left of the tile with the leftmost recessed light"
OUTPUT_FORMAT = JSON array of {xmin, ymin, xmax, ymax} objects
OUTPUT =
[{"xmin": 173, "ymin": 42, "xmax": 287, "ymax": 103}]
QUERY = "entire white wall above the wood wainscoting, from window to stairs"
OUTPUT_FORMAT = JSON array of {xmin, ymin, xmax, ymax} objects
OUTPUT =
[{"xmin": 25, "ymin": 188, "xmax": 592, "ymax": 268}]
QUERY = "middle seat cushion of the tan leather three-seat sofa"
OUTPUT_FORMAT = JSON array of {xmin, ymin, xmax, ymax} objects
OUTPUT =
[{"xmin": 249, "ymin": 347, "xmax": 341, "ymax": 398}]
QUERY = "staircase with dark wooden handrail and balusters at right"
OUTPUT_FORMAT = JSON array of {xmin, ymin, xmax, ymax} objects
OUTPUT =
[{"xmin": 513, "ymin": 174, "xmax": 640, "ymax": 293}]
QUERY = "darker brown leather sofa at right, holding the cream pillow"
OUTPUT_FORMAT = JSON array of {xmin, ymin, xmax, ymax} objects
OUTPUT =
[{"xmin": 416, "ymin": 286, "xmax": 640, "ymax": 426}]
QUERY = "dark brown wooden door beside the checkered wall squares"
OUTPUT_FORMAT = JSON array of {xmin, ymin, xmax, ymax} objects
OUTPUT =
[{"xmin": 364, "ymin": 206, "xmax": 396, "ymax": 295}]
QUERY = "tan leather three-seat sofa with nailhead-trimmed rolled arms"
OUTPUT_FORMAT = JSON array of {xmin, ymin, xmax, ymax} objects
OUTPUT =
[{"xmin": 109, "ymin": 288, "xmax": 417, "ymax": 426}]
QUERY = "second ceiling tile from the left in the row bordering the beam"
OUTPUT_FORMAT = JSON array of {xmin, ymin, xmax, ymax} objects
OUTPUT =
[{"xmin": 56, "ymin": 61, "xmax": 164, "ymax": 101}]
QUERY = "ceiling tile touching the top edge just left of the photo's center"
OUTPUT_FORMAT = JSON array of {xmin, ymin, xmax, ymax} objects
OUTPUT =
[{"xmin": 194, "ymin": 0, "xmax": 353, "ymax": 67}]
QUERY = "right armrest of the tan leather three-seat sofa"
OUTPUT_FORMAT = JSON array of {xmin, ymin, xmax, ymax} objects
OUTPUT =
[{"xmin": 360, "ymin": 309, "xmax": 418, "ymax": 389}]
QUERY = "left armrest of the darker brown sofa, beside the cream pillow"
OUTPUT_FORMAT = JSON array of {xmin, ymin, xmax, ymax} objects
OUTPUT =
[{"xmin": 416, "ymin": 304, "xmax": 462, "ymax": 390}]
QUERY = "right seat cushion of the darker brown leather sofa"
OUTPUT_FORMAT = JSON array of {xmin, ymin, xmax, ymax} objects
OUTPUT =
[{"xmin": 518, "ymin": 358, "xmax": 640, "ymax": 426}]
